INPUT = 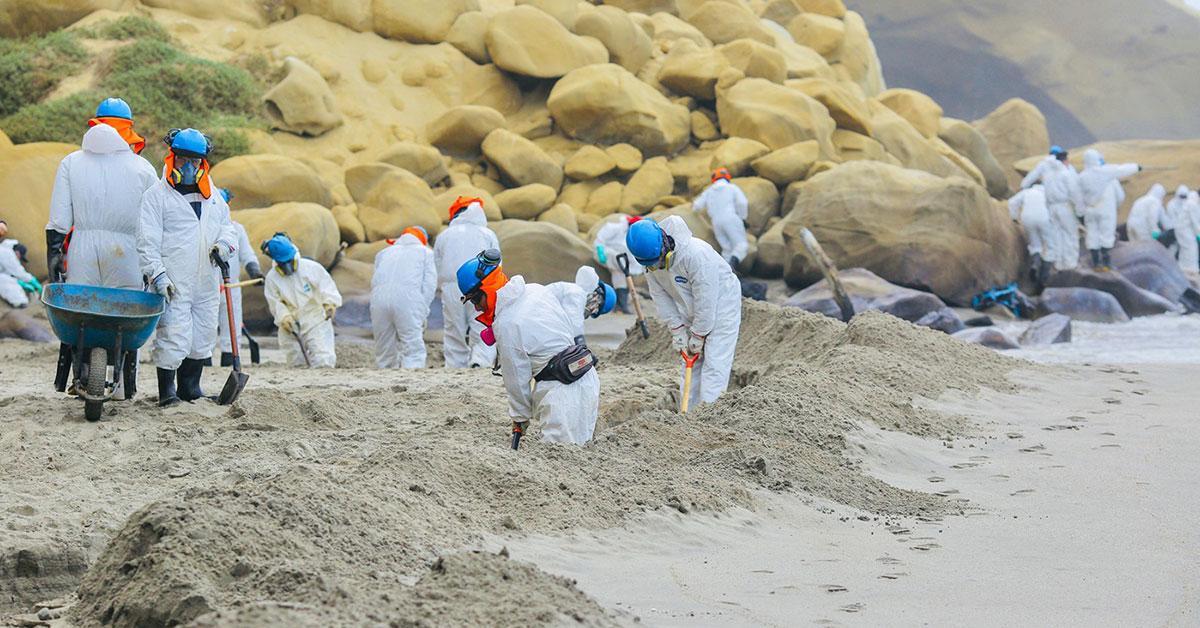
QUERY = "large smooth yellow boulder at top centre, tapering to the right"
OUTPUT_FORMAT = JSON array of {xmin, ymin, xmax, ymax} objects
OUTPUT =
[{"xmin": 486, "ymin": 6, "xmax": 608, "ymax": 78}]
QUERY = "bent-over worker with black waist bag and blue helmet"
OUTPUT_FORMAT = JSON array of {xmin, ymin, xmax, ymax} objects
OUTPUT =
[{"xmin": 457, "ymin": 250, "xmax": 617, "ymax": 447}]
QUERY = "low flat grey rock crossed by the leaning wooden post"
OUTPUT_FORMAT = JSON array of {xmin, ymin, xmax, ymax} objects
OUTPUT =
[{"xmin": 784, "ymin": 268, "xmax": 946, "ymax": 322}]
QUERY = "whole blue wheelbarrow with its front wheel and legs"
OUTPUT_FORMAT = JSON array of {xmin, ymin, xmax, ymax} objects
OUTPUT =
[{"xmin": 42, "ymin": 283, "xmax": 166, "ymax": 420}]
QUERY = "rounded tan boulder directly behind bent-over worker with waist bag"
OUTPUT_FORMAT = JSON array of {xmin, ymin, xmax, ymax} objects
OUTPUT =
[{"xmin": 491, "ymin": 220, "xmax": 607, "ymax": 285}]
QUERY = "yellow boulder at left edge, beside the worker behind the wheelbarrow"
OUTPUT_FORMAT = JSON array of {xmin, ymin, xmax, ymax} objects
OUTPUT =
[{"xmin": 0, "ymin": 142, "xmax": 76, "ymax": 279}]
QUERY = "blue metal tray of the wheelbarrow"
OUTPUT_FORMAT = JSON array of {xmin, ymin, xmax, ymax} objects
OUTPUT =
[{"xmin": 42, "ymin": 283, "xmax": 166, "ymax": 355}]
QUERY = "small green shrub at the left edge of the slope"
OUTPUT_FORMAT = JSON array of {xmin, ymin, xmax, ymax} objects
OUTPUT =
[{"xmin": 0, "ymin": 30, "xmax": 88, "ymax": 116}]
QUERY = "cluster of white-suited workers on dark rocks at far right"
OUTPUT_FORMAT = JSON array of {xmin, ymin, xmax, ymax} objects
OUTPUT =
[{"xmin": 1008, "ymin": 146, "xmax": 1200, "ymax": 286}]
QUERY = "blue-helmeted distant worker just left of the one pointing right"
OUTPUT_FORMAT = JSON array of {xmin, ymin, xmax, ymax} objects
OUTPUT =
[{"xmin": 1021, "ymin": 146, "xmax": 1084, "ymax": 270}]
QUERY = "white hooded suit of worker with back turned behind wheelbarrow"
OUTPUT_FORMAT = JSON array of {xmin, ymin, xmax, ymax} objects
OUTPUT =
[{"xmin": 46, "ymin": 124, "xmax": 157, "ymax": 286}]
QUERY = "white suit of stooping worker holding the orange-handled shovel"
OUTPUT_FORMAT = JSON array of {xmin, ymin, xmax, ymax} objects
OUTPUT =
[{"xmin": 647, "ymin": 216, "xmax": 742, "ymax": 406}]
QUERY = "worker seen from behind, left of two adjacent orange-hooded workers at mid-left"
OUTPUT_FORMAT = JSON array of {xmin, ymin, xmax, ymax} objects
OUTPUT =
[{"xmin": 371, "ymin": 227, "xmax": 438, "ymax": 369}]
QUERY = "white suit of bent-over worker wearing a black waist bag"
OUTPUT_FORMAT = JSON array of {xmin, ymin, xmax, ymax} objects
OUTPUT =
[{"xmin": 492, "ymin": 275, "xmax": 600, "ymax": 444}]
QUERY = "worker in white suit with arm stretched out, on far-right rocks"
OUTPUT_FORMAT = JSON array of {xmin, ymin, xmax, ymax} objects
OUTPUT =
[{"xmin": 1079, "ymin": 149, "xmax": 1141, "ymax": 271}]
